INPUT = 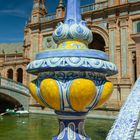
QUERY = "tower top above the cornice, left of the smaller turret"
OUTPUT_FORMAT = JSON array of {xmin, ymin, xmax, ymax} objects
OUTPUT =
[{"xmin": 31, "ymin": 0, "xmax": 47, "ymax": 23}]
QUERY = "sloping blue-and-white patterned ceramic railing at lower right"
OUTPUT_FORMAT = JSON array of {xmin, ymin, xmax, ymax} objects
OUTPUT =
[{"xmin": 106, "ymin": 77, "xmax": 140, "ymax": 140}]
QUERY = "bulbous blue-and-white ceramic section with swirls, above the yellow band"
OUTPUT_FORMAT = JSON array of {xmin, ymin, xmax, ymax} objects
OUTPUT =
[{"xmin": 53, "ymin": 22, "xmax": 93, "ymax": 44}]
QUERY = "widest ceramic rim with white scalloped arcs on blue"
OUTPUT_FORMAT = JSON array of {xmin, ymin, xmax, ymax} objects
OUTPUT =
[{"xmin": 27, "ymin": 57, "xmax": 117, "ymax": 76}]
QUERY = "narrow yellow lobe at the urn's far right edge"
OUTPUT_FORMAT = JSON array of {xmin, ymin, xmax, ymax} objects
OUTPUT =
[{"xmin": 95, "ymin": 82, "xmax": 113, "ymax": 108}]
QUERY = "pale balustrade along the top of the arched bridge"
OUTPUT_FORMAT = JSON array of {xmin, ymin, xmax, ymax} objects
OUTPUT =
[{"xmin": 0, "ymin": 77, "xmax": 29, "ymax": 96}]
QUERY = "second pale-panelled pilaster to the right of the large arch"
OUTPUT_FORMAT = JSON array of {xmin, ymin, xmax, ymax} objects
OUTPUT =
[{"xmin": 119, "ymin": 16, "xmax": 131, "ymax": 104}]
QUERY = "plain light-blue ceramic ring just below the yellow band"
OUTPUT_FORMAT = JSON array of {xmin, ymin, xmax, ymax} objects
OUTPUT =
[{"xmin": 36, "ymin": 49, "xmax": 109, "ymax": 61}]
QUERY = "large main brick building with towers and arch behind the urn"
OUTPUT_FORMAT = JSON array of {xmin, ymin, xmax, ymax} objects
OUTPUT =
[{"xmin": 0, "ymin": 0, "xmax": 140, "ymax": 108}]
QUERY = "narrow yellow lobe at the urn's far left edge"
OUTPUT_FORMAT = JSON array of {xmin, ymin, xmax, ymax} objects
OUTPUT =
[{"xmin": 29, "ymin": 82, "xmax": 45, "ymax": 106}]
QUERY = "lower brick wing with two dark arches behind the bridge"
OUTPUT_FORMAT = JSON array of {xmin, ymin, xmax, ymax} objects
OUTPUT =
[{"xmin": 0, "ymin": 43, "xmax": 30, "ymax": 85}]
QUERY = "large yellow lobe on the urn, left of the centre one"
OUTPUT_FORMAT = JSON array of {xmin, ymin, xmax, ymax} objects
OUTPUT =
[{"xmin": 40, "ymin": 79, "xmax": 61, "ymax": 110}]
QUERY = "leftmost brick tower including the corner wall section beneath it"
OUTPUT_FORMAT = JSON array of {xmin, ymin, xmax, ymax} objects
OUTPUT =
[{"xmin": 24, "ymin": 0, "xmax": 47, "ymax": 63}]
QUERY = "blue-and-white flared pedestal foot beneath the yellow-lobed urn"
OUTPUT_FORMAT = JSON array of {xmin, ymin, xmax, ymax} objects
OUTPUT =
[{"xmin": 53, "ymin": 114, "xmax": 91, "ymax": 140}]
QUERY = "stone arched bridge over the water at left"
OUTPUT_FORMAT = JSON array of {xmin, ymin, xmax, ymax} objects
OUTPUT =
[{"xmin": 0, "ymin": 77, "xmax": 30, "ymax": 113}]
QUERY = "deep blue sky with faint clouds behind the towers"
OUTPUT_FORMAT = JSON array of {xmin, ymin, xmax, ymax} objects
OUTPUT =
[{"xmin": 0, "ymin": 0, "xmax": 94, "ymax": 43}]
